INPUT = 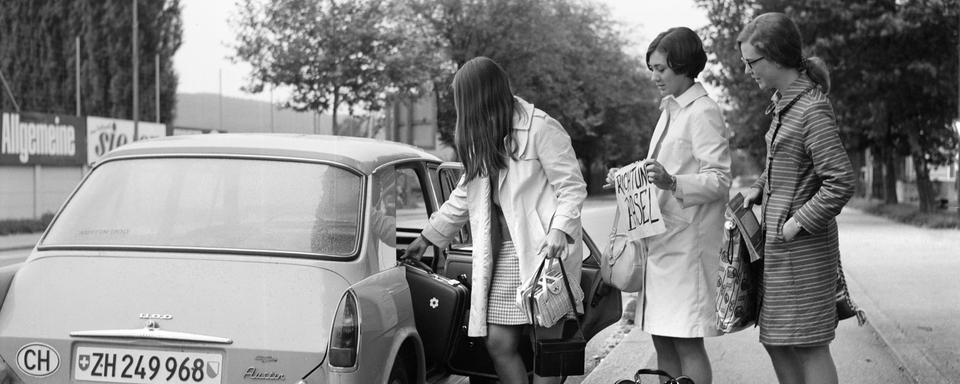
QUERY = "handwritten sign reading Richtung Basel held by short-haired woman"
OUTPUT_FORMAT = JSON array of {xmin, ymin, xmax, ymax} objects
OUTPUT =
[{"xmin": 614, "ymin": 160, "xmax": 667, "ymax": 240}]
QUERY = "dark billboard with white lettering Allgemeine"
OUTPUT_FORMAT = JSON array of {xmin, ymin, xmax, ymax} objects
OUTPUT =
[{"xmin": 0, "ymin": 112, "xmax": 87, "ymax": 165}]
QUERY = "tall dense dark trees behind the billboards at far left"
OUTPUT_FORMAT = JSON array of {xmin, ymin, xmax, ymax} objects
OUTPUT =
[{"xmin": 0, "ymin": 0, "xmax": 183, "ymax": 121}]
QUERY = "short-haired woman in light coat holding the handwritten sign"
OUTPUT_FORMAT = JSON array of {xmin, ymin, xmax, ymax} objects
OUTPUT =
[{"xmin": 607, "ymin": 27, "xmax": 730, "ymax": 384}]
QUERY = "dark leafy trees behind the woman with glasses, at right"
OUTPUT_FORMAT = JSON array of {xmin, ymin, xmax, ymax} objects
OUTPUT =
[{"xmin": 698, "ymin": 0, "xmax": 958, "ymax": 211}]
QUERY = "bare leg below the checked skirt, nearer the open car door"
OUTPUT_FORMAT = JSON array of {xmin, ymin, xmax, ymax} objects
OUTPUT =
[{"xmin": 487, "ymin": 324, "xmax": 527, "ymax": 384}]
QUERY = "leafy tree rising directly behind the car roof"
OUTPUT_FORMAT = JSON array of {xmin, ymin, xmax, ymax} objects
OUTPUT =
[{"xmin": 234, "ymin": 0, "xmax": 442, "ymax": 134}]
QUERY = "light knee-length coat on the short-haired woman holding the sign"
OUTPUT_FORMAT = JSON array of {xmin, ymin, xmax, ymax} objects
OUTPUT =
[{"xmin": 638, "ymin": 83, "xmax": 730, "ymax": 337}]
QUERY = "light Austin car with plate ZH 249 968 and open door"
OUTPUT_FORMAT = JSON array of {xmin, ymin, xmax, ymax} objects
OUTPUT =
[{"xmin": 0, "ymin": 134, "xmax": 620, "ymax": 384}]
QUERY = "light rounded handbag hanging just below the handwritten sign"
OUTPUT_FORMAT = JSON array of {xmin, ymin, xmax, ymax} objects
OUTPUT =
[{"xmin": 600, "ymin": 208, "xmax": 647, "ymax": 292}]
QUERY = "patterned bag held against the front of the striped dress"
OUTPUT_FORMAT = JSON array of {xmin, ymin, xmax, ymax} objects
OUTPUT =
[{"xmin": 716, "ymin": 207, "xmax": 763, "ymax": 333}]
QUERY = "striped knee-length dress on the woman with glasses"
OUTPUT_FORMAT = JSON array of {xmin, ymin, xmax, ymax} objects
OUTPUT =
[{"xmin": 754, "ymin": 74, "xmax": 854, "ymax": 346}]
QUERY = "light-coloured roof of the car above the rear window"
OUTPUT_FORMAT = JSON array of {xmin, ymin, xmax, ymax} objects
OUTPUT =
[{"xmin": 100, "ymin": 133, "xmax": 441, "ymax": 174}]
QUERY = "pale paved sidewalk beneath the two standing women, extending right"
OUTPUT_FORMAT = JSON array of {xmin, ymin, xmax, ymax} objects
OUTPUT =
[{"xmin": 582, "ymin": 209, "xmax": 960, "ymax": 384}]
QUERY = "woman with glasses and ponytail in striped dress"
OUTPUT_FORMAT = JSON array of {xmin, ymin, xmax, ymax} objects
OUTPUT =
[{"xmin": 737, "ymin": 13, "xmax": 854, "ymax": 384}]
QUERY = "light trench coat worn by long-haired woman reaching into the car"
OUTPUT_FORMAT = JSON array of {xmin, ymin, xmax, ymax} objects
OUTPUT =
[{"xmin": 422, "ymin": 98, "xmax": 587, "ymax": 337}]
